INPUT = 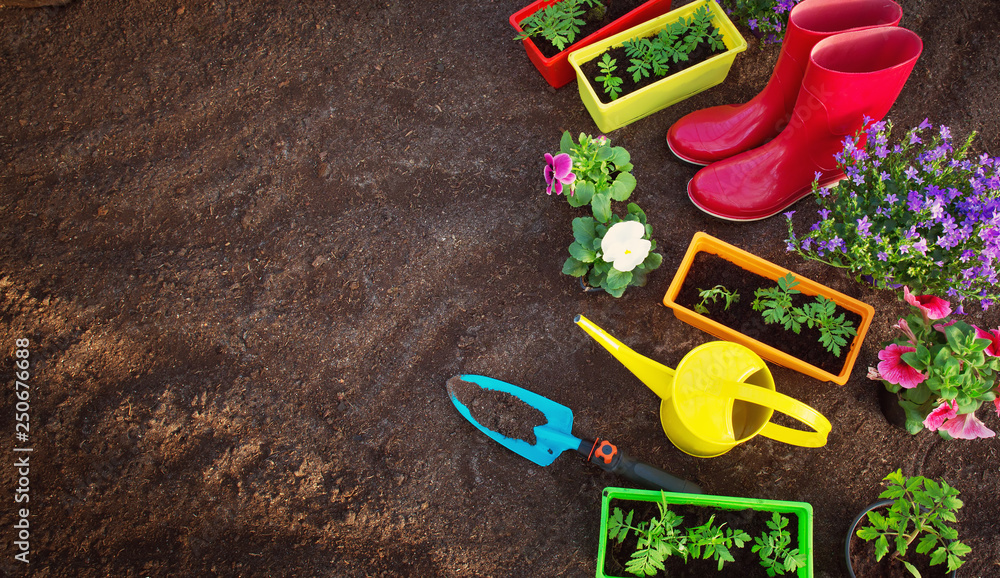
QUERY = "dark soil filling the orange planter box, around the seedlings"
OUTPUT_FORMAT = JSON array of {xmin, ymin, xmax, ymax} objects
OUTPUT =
[{"xmin": 675, "ymin": 252, "xmax": 861, "ymax": 375}]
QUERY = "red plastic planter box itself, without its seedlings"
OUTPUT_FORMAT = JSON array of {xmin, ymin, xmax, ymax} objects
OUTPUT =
[{"xmin": 510, "ymin": 0, "xmax": 671, "ymax": 88}]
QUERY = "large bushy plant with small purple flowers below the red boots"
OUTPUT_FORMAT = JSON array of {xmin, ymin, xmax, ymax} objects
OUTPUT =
[{"xmin": 785, "ymin": 119, "xmax": 1000, "ymax": 313}]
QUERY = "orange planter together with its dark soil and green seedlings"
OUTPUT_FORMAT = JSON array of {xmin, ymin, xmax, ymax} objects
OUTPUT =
[{"xmin": 663, "ymin": 232, "xmax": 875, "ymax": 385}]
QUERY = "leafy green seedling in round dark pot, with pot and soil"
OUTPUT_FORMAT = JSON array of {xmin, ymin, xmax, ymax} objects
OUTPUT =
[{"xmin": 844, "ymin": 470, "xmax": 972, "ymax": 578}]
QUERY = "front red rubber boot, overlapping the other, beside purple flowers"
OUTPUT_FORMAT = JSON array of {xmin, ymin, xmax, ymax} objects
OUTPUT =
[{"xmin": 688, "ymin": 27, "xmax": 923, "ymax": 221}]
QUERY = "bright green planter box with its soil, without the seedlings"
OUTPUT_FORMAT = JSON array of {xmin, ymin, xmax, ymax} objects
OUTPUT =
[{"xmin": 596, "ymin": 487, "xmax": 813, "ymax": 578}]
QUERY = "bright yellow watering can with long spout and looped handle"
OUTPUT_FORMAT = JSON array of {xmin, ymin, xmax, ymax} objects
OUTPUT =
[{"xmin": 574, "ymin": 315, "xmax": 831, "ymax": 458}]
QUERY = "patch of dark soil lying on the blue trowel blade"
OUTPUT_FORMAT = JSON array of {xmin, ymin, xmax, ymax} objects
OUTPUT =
[{"xmin": 447, "ymin": 376, "xmax": 548, "ymax": 445}]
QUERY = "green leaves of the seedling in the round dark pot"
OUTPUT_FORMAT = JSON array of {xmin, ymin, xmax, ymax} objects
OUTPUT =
[{"xmin": 857, "ymin": 470, "xmax": 972, "ymax": 578}]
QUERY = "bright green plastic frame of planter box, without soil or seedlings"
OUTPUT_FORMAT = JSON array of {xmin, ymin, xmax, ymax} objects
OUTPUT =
[{"xmin": 597, "ymin": 488, "xmax": 813, "ymax": 578}]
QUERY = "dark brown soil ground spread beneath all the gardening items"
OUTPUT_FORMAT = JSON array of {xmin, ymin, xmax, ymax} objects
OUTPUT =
[{"xmin": 0, "ymin": 0, "xmax": 1000, "ymax": 577}]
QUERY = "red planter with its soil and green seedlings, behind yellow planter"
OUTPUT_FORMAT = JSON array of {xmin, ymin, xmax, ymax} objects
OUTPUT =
[{"xmin": 510, "ymin": 0, "xmax": 671, "ymax": 88}]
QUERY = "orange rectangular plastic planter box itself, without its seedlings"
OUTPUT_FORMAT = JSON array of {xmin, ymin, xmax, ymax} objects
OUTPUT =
[{"xmin": 663, "ymin": 232, "xmax": 875, "ymax": 385}]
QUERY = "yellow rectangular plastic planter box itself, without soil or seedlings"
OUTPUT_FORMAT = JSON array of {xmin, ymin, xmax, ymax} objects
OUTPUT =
[{"xmin": 569, "ymin": 0, "xmax": 747, "ymax": 132}]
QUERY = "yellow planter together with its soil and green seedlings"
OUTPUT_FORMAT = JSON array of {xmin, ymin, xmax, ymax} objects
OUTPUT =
[{"xmin": 569, "ymin": 0, "xmax": 747, "ymax": 132}]
